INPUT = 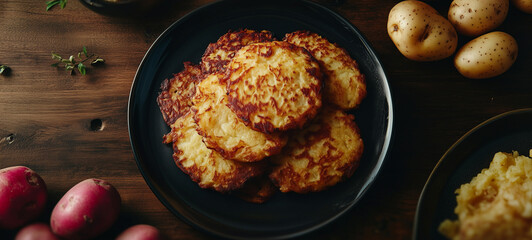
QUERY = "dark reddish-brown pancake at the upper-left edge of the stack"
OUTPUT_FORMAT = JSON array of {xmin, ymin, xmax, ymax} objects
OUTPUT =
[{"xmin": 157, "ymin": 62, "xmax": 202, "ymax": 126}]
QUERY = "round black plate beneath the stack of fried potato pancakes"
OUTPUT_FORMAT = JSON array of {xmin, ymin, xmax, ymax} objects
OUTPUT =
[{"xmin": 128, "ymin": 0, "xmax": 393, "ymax": 239}]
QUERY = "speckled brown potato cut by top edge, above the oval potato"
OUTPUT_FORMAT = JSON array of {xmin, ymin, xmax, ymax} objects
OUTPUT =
[{"xmin": 447, "ymin": 0, "xmax": 510, "ymax": 36}]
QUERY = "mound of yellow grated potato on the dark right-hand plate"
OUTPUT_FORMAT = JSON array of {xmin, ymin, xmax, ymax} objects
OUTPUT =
[{"xmin": 438, "ymin": 149, "xmax": 532, "ymax": 240}]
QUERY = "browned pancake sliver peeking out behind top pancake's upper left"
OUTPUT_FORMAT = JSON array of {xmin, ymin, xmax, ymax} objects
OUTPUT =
[{"xmin": 201, "ymin": 29, "xmax": 275, "ymax": 74}]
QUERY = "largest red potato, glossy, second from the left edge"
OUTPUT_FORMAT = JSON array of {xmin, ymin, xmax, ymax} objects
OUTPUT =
[{"xmin": 50, "ymin": 178, "xmax": 121, "ymax": 239}]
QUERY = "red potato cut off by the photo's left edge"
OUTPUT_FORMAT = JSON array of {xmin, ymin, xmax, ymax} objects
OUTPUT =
[{"xmin": 0, "ymin": 166, "xmax": 47, "ymax": 229}]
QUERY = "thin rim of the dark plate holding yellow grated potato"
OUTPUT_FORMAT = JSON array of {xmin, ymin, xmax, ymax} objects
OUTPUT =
[{"xmin": 412, "ymin": 108, "xmax": 532, "ymax": 240}]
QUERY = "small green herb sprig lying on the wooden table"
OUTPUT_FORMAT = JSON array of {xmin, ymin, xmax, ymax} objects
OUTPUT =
[{"xmin": 52, "ymin": 46, "xmax": 105, "ymax": 75}]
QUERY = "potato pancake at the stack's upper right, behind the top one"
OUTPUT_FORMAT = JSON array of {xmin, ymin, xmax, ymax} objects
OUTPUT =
[{"xmin": 284, "ymin": 31, "xmax": 366, "ymax": 110}]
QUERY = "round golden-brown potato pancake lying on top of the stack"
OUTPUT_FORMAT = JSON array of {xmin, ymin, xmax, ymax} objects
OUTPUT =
[{"xmin": 226, "ymin": 41, "xmax": 322, "ymax": 133}]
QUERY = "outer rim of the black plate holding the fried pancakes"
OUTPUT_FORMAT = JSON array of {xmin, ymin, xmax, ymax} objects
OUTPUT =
[{"xmin": 127, "ymin": 0, "xmax": 395, "ymax": 239}]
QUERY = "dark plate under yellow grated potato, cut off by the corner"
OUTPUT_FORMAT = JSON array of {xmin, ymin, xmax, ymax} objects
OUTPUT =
[{"xmin": 414, "ymin": 108, "xmax": 532, "ymax": 239}]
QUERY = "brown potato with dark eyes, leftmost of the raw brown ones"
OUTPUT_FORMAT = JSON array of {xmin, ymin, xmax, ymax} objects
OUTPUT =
[{"xmin": 388, "ymin": 1, "xmax": 458, "ymax": 61}]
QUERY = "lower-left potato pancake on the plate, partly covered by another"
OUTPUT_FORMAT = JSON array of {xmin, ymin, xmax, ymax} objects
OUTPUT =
[{"xmin": 163, "ymin": 111, "xmax": 265, "ymax": 193}]
